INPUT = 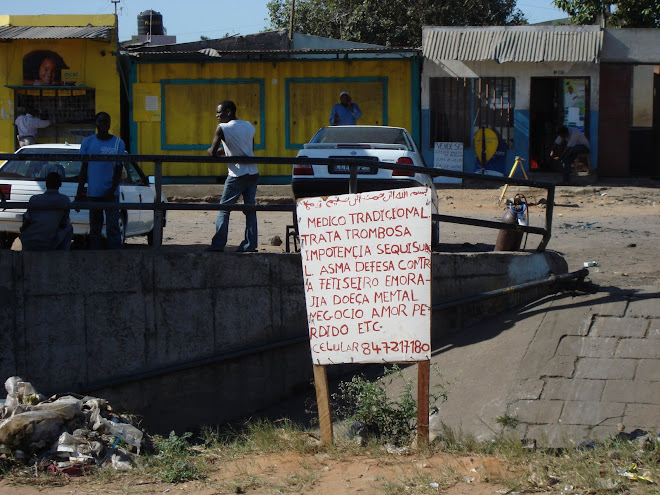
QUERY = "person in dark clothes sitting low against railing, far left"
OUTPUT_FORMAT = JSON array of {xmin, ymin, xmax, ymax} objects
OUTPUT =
[{"xmin": 21, "ymin": 172, "xmax": 73, "ymax": 251}]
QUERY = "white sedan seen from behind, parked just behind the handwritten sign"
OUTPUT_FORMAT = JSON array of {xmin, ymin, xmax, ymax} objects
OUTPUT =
[{"xmin": 291, "ymin": 125, "xmax": 439, "ymax": 246}]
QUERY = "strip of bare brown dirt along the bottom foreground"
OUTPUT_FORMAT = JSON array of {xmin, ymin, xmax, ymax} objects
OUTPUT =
[{"xmin": 0, "ymin": 452, "xmax": 513, "ymax": 495}]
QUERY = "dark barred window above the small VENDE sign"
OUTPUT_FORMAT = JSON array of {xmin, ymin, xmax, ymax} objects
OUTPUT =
[{"xmin": 429, "ymin": 77, "xmax": 515, "ymax": 149}]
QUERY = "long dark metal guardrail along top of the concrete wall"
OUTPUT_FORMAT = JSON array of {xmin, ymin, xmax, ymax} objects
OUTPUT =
[{"xmin": 0, "ymin": 153, "xmax": 555, "ymax": 252}]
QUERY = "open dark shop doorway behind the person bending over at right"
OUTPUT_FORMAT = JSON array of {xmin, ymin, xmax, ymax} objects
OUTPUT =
[{"xmin": 529, "ymin": 77, "xmax": 590, "ymax": 172}]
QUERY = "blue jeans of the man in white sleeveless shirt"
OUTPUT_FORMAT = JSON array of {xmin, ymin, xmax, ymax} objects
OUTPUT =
[{"xmin": 211, "ymin": 174, "xmax": 259, "ymax": 252}]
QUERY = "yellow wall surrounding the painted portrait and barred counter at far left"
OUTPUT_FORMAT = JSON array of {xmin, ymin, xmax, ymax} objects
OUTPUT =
[{"xmin": 0, "ymin": 15, "xmax": 120, "ymax": 153}]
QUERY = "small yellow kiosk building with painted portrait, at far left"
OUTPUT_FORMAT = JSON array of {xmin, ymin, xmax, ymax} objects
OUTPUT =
[{"xmin": 0, "ymin": 15, "xmax": 120, "ymax": 153}]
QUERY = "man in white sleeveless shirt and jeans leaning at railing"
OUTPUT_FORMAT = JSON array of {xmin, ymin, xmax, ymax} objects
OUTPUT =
[{"xmin": 206, "ymin": 100, "xmax": 259, "ymax": 253}]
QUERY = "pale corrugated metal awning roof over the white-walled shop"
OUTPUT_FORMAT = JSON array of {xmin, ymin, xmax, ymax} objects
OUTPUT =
[{"xmin": 422, "ymin": 26, "xmax": 603, "ymax": 63}]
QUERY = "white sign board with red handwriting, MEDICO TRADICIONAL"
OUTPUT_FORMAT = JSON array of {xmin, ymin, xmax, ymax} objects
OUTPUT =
[{"xmin": 296, "ymin": 187, "xmax": 431, "ymax": 365}]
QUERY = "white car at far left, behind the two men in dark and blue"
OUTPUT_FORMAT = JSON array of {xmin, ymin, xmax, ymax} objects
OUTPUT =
[{"xmin": 0, "ymin": 144, "xmax": 167, "ymax": 249}]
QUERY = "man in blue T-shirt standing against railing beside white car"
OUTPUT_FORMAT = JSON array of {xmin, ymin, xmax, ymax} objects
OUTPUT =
[{"xmin": 75, "ymin": 112, "xmax": 126, "ymax": 249}]
